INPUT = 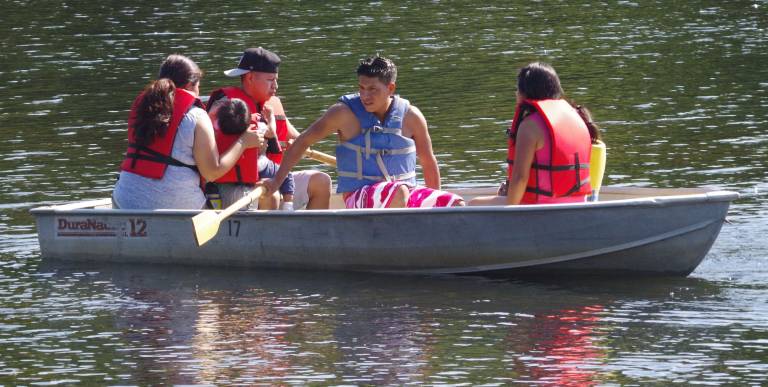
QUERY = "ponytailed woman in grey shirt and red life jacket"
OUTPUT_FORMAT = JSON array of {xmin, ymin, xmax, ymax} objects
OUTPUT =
[{"xmin": 112, "ymin": 54, "xmax": 263, "ymax": 209}]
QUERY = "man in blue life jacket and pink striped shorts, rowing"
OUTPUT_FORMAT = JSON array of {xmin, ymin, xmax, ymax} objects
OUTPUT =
[{"xmin": 263, "ymin": 56, "xmax": 464, "ymax": 208}]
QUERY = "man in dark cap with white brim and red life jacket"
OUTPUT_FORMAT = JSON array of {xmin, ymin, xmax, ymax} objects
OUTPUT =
[{"xmin": 207, "ymin": 47, "xmax": 331, "ymax": 209}]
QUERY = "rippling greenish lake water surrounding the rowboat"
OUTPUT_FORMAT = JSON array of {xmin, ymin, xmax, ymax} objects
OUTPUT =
[{"xmin": 0, "ymin": 1, "xmax": 768, "ymax": 385}]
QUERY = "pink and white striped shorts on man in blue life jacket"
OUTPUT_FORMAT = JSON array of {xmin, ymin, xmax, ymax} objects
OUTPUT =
[{"xmin": 344, "ymin": 181, "xmax": 464, "ymax": 208}]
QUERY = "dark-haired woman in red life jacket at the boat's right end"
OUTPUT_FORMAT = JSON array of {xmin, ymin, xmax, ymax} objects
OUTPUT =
[{"xmin": 470, "ymin": 62, "xmax": 600, "ymax": 205}]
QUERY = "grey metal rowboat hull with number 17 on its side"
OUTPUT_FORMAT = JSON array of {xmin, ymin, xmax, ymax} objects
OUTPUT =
[{"xmin": 32, "ymin": 190, "xmax": 738, "ymax": 276}]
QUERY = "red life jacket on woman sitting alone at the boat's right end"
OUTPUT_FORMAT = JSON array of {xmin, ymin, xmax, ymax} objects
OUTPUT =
[{"xmin": 507, "ymin": 99, "xmax": 592, "ymax": 204}]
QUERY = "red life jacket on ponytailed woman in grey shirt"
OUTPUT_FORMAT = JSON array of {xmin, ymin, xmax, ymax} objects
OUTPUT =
[{"xmin": 120, "ymin": 87, "xmax": 203, "ymax": 179}]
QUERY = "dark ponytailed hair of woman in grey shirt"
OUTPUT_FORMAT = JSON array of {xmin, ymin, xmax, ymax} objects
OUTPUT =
[{"xmin": 133, "ymin": 54, "xmax": 203, "ymax": 145}]
